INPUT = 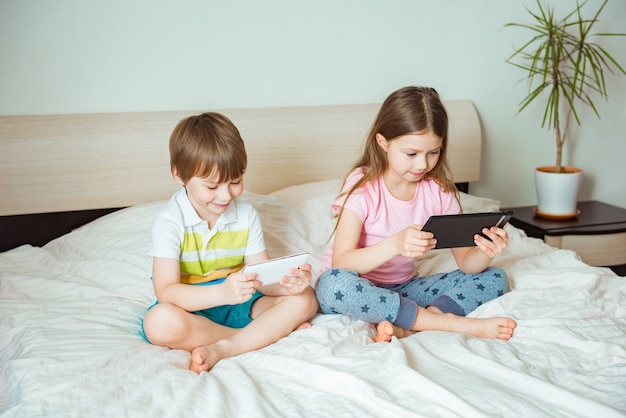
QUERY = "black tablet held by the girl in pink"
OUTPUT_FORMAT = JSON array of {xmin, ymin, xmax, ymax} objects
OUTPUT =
[{"xmin": 422, "ymin": 211, "xmax": 513, "ymax": 248}]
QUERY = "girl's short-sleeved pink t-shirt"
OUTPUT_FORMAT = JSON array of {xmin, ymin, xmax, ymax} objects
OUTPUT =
[{"xmin": 322, "ymin": 169, "xmax": 461, "ymax": 284}]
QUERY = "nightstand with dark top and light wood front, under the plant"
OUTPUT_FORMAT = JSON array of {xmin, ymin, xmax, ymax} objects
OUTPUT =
[{"xmin": 506, "ymin": 200, "xmax": 626, "ymax": 276}]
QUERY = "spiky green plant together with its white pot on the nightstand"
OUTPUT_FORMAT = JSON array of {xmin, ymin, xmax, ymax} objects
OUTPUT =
[{"xmin": 505, "ymin": 0, "xmax": 626, "ymax": 219}]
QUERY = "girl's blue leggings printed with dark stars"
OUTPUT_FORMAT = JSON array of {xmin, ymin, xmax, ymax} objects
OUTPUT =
[{"xmin": 315, "ymin": 267, "xmax": 509, "ymax": 329}]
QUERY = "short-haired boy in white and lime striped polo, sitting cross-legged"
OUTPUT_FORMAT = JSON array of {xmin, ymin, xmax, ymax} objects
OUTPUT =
[{"xmin": 143, "ymin": 113, "xmax": 318, "ymax": 373}]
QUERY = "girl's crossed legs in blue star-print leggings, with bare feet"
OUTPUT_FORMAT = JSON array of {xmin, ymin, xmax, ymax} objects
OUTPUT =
[{"xmin": 316, "ymin": 267, "xmax": 517, "ymax": 341}]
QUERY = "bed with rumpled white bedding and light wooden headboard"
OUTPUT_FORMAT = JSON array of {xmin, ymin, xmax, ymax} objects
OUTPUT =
[{"xmin": 0, "ymin": 100, "xmax": 626, "ymax": 417}]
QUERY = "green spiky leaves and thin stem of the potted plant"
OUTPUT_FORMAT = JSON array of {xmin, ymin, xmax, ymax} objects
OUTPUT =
[{"xmin": 505, "ymin": 0, "xmax": 626, "ymax": 172}]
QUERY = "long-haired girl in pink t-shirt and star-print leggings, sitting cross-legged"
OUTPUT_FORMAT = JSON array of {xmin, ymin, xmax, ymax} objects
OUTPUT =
[{"xmin": 316, "ymin": 87, "xmax": 517, "ymax": 341}]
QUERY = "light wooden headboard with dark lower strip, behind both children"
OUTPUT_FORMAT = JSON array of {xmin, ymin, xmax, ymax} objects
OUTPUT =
[{"xmin": 0, "ymin": 100, "xmax": 482, "ymax": 251}]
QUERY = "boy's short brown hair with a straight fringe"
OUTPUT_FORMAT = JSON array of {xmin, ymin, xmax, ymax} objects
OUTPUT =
[{"xmin": 170, "ymin": 112, "xmax": 248, "ymax": 183}]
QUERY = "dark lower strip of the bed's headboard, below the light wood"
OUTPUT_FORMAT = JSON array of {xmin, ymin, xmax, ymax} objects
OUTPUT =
[{"xmin": 0, "ymin": 183, "xmax": 469, "ymax": 252}]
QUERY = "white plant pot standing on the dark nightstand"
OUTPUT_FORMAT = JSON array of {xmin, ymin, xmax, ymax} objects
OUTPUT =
[{"xmin": 535, "ymin": 166, "xmax": 583, "ymax": 217}]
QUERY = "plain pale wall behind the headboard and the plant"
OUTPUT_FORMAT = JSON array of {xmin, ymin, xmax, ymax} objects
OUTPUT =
[{"xmin": 0, "ymin": 0, "xmax": 626, "ymax": 207}]
